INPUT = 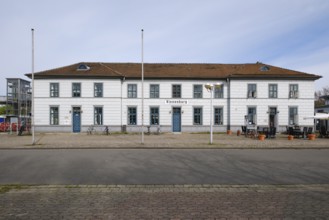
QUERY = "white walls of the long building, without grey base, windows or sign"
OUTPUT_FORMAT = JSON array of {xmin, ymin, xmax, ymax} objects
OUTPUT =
[{"xmin": 35, "ymin": 79, "xmax": 314, "ymax": 131}]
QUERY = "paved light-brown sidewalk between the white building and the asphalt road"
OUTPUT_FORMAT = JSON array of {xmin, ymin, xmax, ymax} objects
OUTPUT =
[{"xmin": 0, "ymin": 133, "xmax": 329, "ymax": 149}]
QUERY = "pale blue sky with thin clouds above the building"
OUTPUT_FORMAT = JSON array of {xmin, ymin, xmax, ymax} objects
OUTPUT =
[{"xmin": 0, "ymin": 0, "xmax": 329, "ymax": 95}]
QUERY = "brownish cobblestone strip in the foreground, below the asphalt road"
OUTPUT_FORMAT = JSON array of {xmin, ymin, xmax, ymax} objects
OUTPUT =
[{"xmin": 0, "ymin": 184, "xmax": 329, "ymax": 220}]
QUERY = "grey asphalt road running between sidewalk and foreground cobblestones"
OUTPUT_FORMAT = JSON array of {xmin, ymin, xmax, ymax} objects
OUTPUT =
[{"xmin": 0, "ymin": 149, "xmax": 329, "ymax": 184}]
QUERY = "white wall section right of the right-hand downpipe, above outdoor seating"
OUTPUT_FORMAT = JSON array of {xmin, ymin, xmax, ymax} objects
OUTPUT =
[{"xmin": 231, "ymin": 80, "xmax": 314, "ymax": 126}]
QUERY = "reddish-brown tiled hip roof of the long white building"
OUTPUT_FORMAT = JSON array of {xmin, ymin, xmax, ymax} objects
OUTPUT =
[{"xmin": 26, "ymin": 62, "xmax": 321, "ymax": 80}]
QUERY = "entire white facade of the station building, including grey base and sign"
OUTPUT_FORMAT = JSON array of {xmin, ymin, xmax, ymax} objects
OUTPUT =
[{"xmin": 34, "ymin": 78, "xmax": 314, "ymax": 132}]
